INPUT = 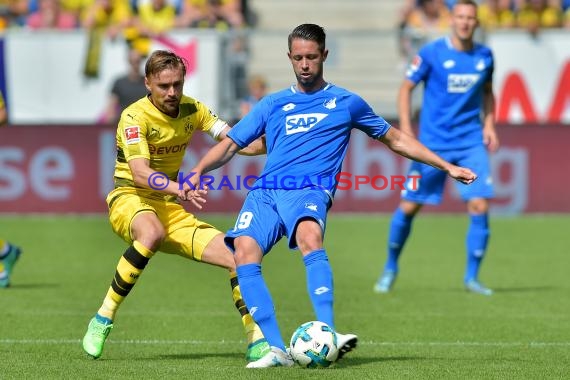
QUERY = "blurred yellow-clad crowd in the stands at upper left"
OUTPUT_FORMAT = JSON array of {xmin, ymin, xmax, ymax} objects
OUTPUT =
[{"xmin": 0, "ymin": 0, "xmax": 255, "ymax": 55}]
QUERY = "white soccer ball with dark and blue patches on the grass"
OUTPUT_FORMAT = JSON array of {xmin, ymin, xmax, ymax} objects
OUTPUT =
[{"xmin": 289, "ymin": 321, "xmax": 338, "ymax": 368}]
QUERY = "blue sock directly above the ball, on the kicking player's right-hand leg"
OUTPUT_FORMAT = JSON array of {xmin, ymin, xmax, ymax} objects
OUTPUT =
[{"xmin": 303, "ymin": 249, "xmax": 334, "ymax": 328}]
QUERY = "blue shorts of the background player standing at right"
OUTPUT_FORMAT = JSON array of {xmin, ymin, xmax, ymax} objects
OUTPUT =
[{"xmin": 402, "ymin": 145, "xmax": 494, "ymax": 205}]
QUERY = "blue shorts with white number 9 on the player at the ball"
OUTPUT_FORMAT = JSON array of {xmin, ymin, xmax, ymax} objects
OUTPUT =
[{"xmin": 225, "ymin": 188, "xmax": 331, "ymax": 255}]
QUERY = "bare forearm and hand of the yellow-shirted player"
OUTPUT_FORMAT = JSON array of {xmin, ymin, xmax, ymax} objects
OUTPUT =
[{"xmin": 129, "ymin": 158, "xmax": 207, "ymax": 209}]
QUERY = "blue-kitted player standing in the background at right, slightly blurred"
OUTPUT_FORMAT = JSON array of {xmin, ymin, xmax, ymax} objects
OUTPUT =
[{"xmin": 374, "ymin": 0, "xmax": 499, "ymax": 295}]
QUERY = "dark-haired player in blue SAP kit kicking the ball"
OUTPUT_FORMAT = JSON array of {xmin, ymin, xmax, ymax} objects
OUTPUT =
[{"xmin": 193, "ymin": 24, "xmax": 476, "ymax": 368}]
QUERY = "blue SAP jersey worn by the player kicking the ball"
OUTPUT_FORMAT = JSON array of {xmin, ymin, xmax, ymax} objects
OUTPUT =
[{"xmin": 228, "ymin": 84, "xmax": 390, "ymax": 196}]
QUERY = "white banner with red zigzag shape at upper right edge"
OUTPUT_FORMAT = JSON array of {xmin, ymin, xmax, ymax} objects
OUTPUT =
[{"xmin": 489, "ymin": 30, "xmax": 570, "ymax": 124}]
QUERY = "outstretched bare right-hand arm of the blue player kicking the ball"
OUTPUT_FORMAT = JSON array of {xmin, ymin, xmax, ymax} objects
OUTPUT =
[{"xmin": 380, "ymin": 128, "xmax": 477, "ymax": 184}]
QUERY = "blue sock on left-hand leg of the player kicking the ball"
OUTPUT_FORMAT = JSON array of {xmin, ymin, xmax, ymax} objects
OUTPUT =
[{"xmin": 236, "ymin": 264, "xmax": 285, "ymax": 351}]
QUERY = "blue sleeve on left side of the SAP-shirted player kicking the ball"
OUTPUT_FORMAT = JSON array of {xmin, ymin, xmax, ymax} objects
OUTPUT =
[{"xmin": 228, "ymin": 96, "xmax": 271, "ymax": 148}]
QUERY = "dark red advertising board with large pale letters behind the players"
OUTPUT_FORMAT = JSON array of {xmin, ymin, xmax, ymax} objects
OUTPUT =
[{"xmin": 0, "ymin": 125, "xmax": 570, "ymax": 214}]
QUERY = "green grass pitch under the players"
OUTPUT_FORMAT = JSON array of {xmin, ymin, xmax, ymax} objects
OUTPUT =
[{"xmin": 0, "ymin": 213, "xmax": 570, "ymax": 379}]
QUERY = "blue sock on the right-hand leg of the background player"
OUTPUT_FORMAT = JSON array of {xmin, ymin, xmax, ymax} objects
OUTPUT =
[{"xmin": 464, "ymin": 214, "xmax": 489, "ymax": 282}]
